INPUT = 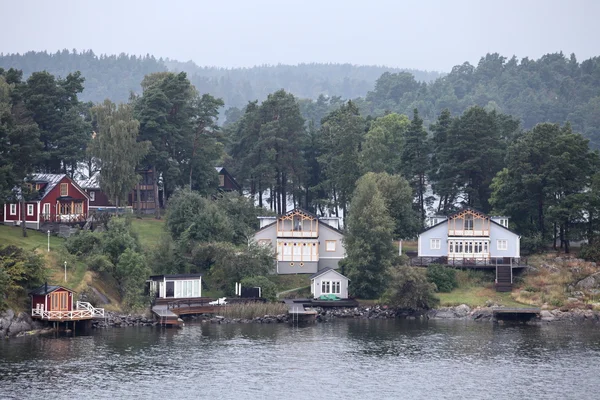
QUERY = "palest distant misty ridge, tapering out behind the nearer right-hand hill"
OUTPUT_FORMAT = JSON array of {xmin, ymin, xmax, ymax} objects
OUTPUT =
[{"xmin": 0, "ymin": 50, "xmax": 441, "ymax": 107}]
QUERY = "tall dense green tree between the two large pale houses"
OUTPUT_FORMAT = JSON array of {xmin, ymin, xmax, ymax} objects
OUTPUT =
[{"xmin": 344, "ymin": 173, "xmax": 394, "ymax": 299}]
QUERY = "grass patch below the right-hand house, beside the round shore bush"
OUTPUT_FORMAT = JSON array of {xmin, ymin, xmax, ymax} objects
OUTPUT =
[{"xmin": 437, "ymin": 286, "xmax": 530, "ymax": 307}]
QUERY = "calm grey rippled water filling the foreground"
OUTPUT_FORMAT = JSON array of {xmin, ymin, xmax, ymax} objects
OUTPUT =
[{"xmin": 0, "ymin": 320, "xmax": 600, "ymax": 400}]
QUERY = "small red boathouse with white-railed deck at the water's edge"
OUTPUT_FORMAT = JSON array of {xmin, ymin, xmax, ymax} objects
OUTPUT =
[{"xmin": 29, "ymin": 284, "xmax": 104, "ymax": 321}]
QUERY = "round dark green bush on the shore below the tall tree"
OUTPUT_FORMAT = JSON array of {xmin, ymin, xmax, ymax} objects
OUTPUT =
[{"xmin": 382, "ymin": 266, "xmax": 439, "ymax": 311}]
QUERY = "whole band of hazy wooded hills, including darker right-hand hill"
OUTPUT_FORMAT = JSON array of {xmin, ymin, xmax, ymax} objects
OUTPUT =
[{"xmin": 0, "ymin": 50, "xmax": 600, "ymax": 148}]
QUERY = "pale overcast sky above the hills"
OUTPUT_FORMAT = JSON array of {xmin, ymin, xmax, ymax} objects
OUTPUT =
[{"xmin": 0, "ymin": 0, "xmax": 600, "ymax": 71}]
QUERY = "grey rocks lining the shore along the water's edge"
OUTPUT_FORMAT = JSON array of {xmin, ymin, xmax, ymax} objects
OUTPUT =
[{"xmin": 0, "ymin": 304, "xmax": 600, "ymax": 338}]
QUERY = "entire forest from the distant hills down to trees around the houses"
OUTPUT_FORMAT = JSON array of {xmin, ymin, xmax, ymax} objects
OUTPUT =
[{"xmin": 0, "ymin": 52, "xmax": 600, "ymax": 305}]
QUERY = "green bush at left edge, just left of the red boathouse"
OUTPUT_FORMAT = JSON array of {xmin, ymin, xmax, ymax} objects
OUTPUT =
[{"xmin": 0, "ymin": 246, "xmax": 46, "ymax": 310}]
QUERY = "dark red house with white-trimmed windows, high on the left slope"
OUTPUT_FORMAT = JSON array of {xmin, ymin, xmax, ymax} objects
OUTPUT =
[{"xmin": 4, "ymin": 174, "xmax": 90, "ymax": 230}]
